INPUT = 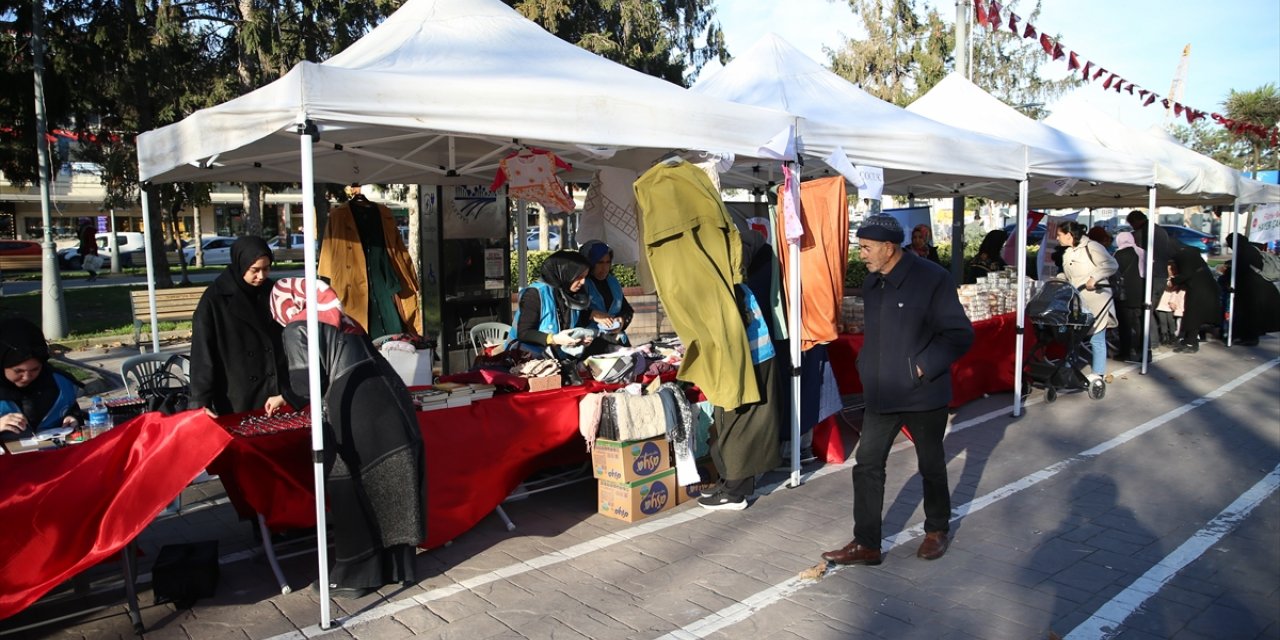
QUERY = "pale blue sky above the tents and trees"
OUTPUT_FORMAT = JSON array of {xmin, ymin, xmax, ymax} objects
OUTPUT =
[{"xmin": 703, "ymin": 0, "xmax": 1280, "ymax": 128}]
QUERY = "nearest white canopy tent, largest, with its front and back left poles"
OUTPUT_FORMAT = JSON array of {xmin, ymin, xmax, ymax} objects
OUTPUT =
[{"xmin": 138, "ymin": 0, "xmax": 796, "ymax": 627}]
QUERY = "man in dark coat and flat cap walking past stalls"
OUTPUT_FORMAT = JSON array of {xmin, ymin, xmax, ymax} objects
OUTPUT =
[{"xmin": 822, "ymin": 215, "xmax": 973, "ymax": 564}]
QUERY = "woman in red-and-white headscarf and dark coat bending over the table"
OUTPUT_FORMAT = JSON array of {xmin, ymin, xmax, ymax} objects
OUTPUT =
[{"xmin": 271, "ymin": 278, "xmax": 426, "ymax": 598}]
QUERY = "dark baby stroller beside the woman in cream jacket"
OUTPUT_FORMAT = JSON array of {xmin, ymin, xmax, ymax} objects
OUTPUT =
[{"xmin": 1023, "ymin": 280, "xmax": 1110, "ymax": 402}]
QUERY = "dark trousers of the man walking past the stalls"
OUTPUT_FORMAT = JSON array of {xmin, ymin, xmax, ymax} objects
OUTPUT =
[{"xmin": 854, "ymin": 407, "xmax": 951, "ymax": 549}]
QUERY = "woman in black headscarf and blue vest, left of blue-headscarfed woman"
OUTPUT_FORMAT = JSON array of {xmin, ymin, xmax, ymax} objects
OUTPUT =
[{"xmin": 508, "ymin": 251, "xmax": 595, "ymax": 358}]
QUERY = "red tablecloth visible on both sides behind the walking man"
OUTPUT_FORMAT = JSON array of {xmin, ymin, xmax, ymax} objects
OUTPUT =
[{"xmin": 814, "ymin": 314, "xmax": 1034, "ymax": 462}]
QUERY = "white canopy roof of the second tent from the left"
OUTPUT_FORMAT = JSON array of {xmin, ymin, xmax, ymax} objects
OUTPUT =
[{"xmin": 691, "ymin": 33, "xmax": 1027, "ymax": 192}]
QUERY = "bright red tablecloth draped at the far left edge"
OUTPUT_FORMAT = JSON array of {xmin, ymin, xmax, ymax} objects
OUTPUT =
[{"xmin": 0, "ymin": 411, "xmax": 230, "ymax": 618}]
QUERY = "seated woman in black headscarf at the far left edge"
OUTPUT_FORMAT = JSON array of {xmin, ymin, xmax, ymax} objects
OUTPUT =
[{"xmin": 0, "ymin": 317, "xmax": 84, "ymax": 442}]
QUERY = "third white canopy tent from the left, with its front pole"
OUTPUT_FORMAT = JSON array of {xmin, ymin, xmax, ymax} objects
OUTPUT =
[{"xmin": 906, "ymin": 73, "xmax": 1156, "ymax": 416}]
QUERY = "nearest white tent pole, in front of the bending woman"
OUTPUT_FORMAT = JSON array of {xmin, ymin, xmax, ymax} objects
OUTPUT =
[{"xmin": 298, "ymin": 120, "xmax": 330, "ymax": 628}]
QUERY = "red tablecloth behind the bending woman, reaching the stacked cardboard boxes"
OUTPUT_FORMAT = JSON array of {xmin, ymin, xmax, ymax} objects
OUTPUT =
[{"xmin": 209, "ymin": 383, "xmax": 608, "ymax": 548}]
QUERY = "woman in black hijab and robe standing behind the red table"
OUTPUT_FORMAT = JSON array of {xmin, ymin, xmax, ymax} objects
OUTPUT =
[{"xmin": 189, "ymin": 236, "xmax": 288, "ymax": 416}]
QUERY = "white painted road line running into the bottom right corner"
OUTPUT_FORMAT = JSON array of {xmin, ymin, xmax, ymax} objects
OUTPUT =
[{"xmin": 1064, "ymin": 466, "xmax": 1280, "ymax": 640}]
